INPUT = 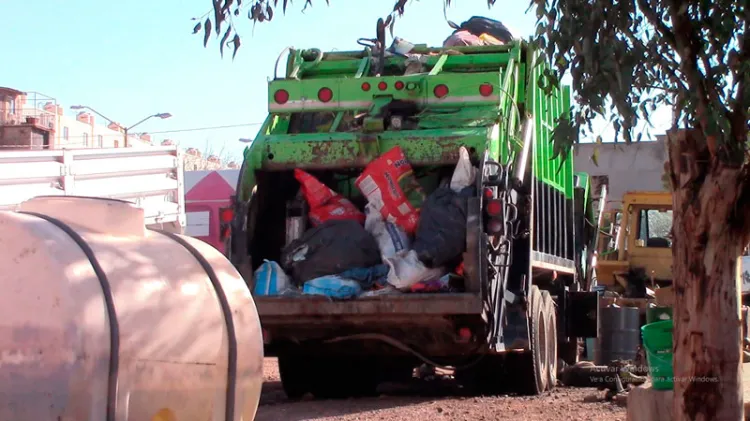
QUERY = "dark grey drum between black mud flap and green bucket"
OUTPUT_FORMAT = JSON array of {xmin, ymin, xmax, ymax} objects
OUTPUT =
[{"xmin": 594, "ymin": 307, "xmax": 641, "ymax": 365}]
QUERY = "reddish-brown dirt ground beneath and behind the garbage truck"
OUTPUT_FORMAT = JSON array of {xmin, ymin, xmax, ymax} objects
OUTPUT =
[{"xmin": 255, "ymin": 358, "xmax": 625, "ymax": 421}]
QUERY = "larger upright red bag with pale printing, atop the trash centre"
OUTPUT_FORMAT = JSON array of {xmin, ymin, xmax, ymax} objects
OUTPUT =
[{"xmin": 354, "ymin": 146, "xmax": 425, "ymax": 234}]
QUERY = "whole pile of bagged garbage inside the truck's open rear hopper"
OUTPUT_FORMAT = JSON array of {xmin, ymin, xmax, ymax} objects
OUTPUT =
[{"xmin": 255, "ymin": 146, "xmax": 477, "ymax": 299}]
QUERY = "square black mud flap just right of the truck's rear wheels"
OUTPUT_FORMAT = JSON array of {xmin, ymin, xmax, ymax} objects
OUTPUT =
[{"xmin": 557, "ymin": 291, "xmax": 599, "ymax": 338}]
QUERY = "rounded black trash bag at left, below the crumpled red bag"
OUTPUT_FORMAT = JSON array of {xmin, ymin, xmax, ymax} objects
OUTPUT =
[{"xmin": 281, "ymin": 220, "xmax": 381, "ymax": 286}]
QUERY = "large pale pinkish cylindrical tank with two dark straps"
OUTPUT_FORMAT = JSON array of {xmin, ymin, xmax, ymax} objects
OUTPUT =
[{"xmin": 0, "ymin": 196, "xmax": 263, "ymax": 421}]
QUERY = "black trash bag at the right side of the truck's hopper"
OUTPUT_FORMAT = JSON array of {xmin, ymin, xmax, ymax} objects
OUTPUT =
[{"xmin": 412, "ymin": 186, "xmax": 475, "ymax": 268}]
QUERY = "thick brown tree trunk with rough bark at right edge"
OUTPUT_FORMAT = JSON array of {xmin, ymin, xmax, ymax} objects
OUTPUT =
[{"xmin": 667, "ymin": 131, "xmax": 747, "ymax": 421}]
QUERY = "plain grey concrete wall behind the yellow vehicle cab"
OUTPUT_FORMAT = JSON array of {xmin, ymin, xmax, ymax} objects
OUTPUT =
[{"xmin": 574, "ymin": 136, "xmax": 667, "ymax": 207}]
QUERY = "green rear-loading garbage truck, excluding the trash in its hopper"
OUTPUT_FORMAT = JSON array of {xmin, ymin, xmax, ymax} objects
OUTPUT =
[{"xmin": 223, "ymin": 36, "xmax": 598, "ymax": 398}]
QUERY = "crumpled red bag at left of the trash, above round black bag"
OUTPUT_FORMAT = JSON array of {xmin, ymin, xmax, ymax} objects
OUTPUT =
[{"xmin": 294, "ymin": 169, "xmax": 365, "ymax": 227}]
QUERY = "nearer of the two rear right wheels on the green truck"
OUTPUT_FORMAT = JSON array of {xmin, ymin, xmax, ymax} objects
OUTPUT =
[{"xmin": 508, "ymin": 285, "xmax": 549, "ymax": 395}]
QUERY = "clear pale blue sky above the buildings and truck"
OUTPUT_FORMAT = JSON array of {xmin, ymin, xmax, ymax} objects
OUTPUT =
[{"xmin": 0, "ymin": 0, "xmax": 668, "ymax": 162}]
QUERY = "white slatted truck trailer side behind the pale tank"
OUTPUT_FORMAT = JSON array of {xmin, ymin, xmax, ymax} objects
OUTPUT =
[{"xmin": 0, "ymin": 146, "xmax": 186, "ymax": 234}]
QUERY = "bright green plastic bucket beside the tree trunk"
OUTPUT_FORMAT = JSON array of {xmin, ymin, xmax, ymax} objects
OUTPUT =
[{"xmin": 641, "ymin": 320, "xmax": 674, "ymax": 390}]
